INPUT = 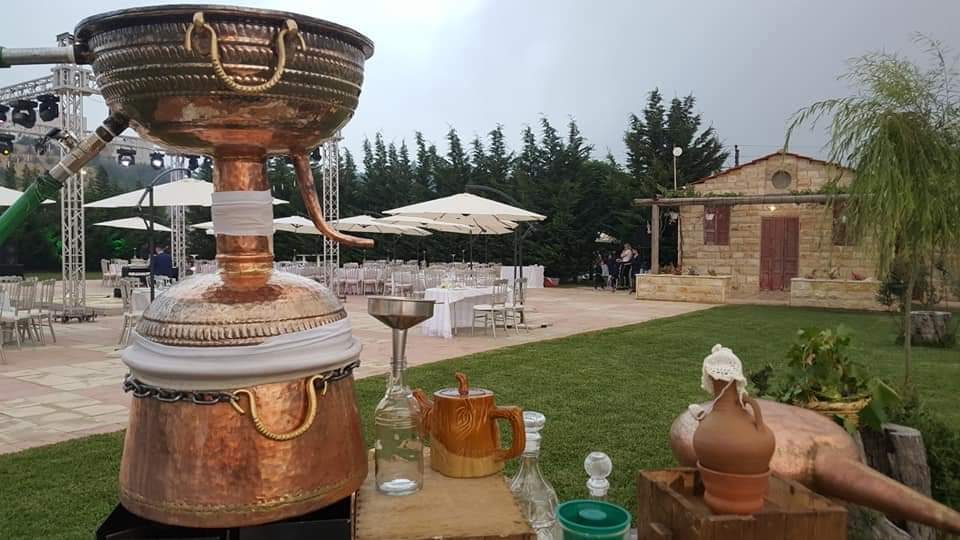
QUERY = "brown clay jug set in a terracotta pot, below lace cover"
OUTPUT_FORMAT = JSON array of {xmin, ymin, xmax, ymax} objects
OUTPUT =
[{"xmin": 693, "ymin": 380, "xmax": 776, "ymax": 514}]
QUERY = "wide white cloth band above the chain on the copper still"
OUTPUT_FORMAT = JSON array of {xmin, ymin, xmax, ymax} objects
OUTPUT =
[{"xmin": 121, "ymin": 317, "xmax": 361, "ymax": 390}]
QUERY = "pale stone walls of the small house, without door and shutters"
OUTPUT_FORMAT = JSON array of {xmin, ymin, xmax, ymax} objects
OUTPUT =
[{"xmin": 681, "ymin": 155, "xmax": 876, "ymax": 296}]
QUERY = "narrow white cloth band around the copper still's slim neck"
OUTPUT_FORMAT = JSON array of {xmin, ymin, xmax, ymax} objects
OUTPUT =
[{"xmin": 210, "ymin": 191, "xmax": 273, "ymax": 236}]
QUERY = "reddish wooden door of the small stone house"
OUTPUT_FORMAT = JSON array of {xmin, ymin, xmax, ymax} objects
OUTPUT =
[{"xmin": 760, "ymin": 218, "xmax": 800, "ymax": 291}]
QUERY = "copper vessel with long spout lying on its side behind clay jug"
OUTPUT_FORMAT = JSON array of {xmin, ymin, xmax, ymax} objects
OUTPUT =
[{"xmin": 670, "ymin": 399, "xmax": 960, "ymax": 534}]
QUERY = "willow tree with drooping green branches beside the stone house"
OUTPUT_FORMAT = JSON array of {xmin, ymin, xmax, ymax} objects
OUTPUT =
[{"xmin": 787, "ymin": 37, "xmax": 960, "ymax": 386}]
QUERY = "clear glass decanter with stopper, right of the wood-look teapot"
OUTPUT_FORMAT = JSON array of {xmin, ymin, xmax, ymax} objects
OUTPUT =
[{"xmin": 510, "ymin": 411, "xmax": 561, "ymax": 540}]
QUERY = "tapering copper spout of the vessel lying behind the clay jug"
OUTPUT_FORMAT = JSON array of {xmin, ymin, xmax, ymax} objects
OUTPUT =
[{"xmin": 813, "ymin": 449, "xmax": 960, "ymax": 534}]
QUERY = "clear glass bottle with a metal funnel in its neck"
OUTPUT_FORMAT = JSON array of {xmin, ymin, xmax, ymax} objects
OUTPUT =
[{"xmin": 367, "ymin": 296, "xmax": 433, "ymax": 495}]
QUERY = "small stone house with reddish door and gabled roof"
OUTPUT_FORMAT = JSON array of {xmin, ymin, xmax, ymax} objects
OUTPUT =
[{"xmin": 679, "ymin": 152, "xmax": 876, "ymax": 296}]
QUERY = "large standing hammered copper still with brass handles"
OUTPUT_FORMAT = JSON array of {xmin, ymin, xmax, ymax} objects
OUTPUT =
[{"xmin": 76, "ymin": 6, "xmax": 373, "ymax": 527}]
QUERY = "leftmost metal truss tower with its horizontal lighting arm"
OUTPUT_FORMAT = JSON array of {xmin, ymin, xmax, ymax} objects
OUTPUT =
[{"xmin": 0, "ymin": 33, "xmax": 99, "ymax": 318}]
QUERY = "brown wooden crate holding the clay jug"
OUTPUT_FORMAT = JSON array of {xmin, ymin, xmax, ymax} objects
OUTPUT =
[{"xmin": 636, "ymin": 468, "xmax": 847, "ymax": 540}]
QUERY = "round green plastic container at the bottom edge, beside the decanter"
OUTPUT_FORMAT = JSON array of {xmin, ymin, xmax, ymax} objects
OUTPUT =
[{"xmin": 557, "ymin": 500, "xmax": 631, "ymax": 540}]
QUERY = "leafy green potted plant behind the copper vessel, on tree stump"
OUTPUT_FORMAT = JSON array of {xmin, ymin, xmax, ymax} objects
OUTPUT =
[{"xmin": 775, "ymin": 326, "xmax": 900, "ymax": 432}]
